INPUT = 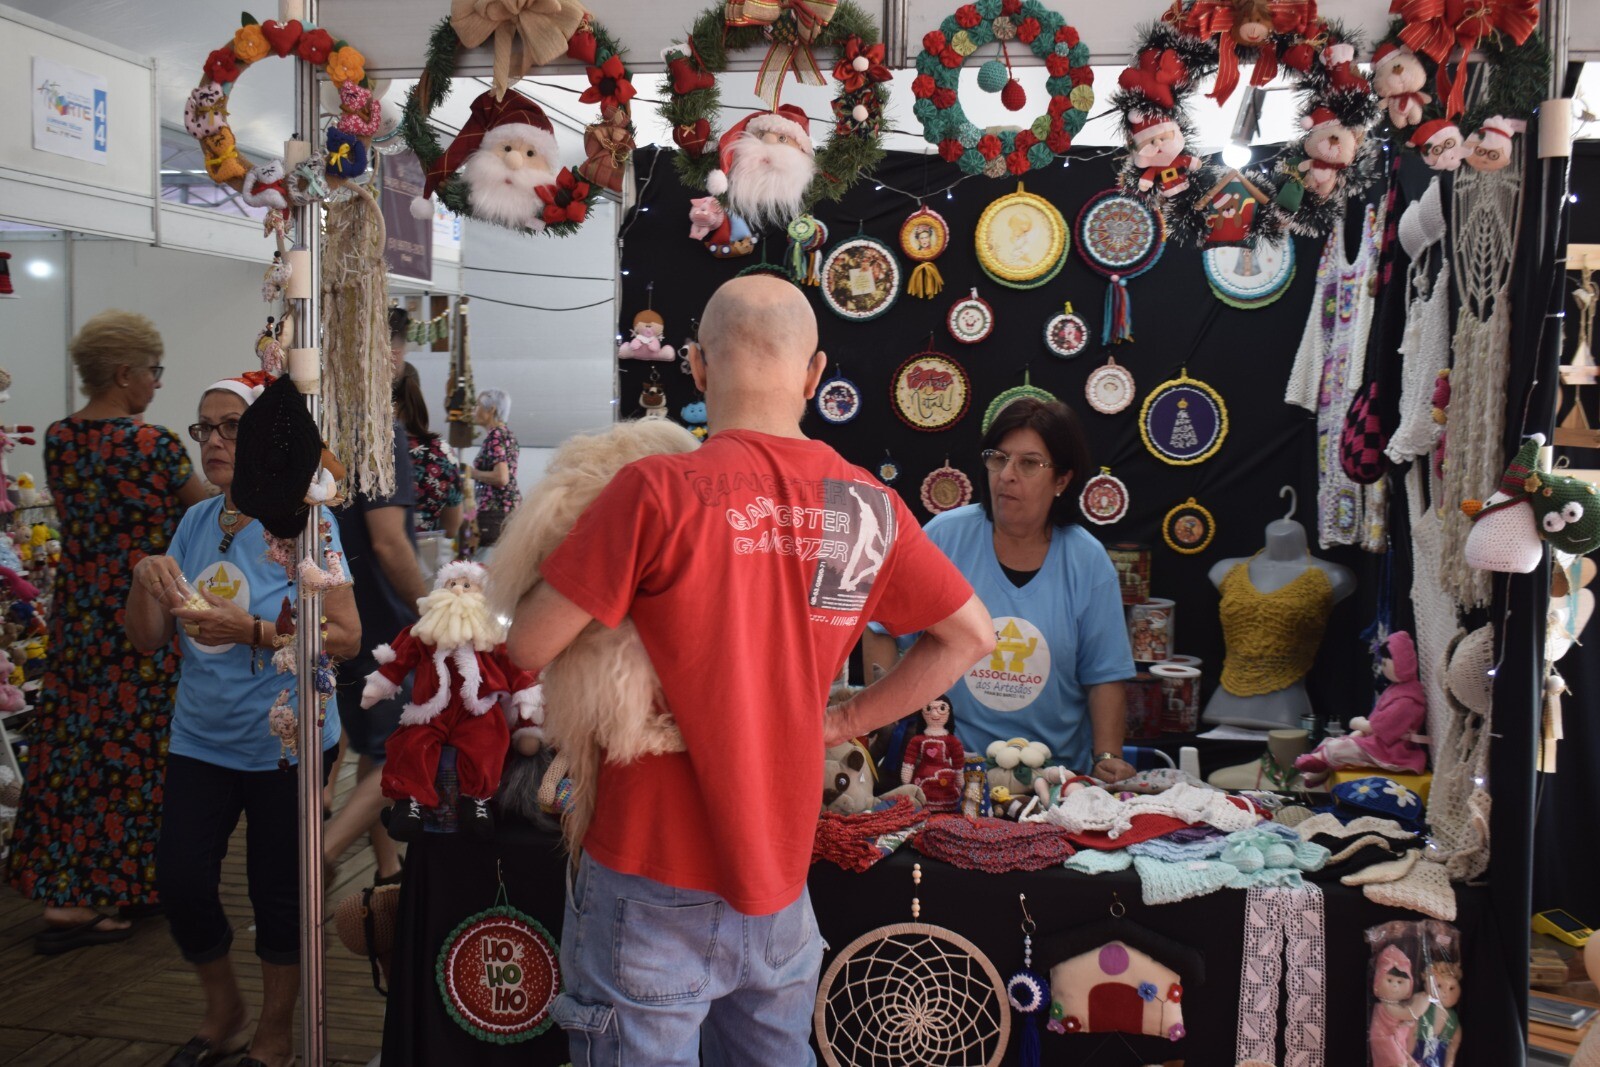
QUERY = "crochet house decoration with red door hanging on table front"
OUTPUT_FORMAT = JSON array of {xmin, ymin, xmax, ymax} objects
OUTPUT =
[{"xmin": 1042, "ymin": 918, "xmax": 1205, "ymax": 1041}]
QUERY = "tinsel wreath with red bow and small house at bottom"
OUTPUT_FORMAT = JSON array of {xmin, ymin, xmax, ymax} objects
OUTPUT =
[{"xmin": 1112, "ymin": 8, "xmax": 1379, "ymax": 245}]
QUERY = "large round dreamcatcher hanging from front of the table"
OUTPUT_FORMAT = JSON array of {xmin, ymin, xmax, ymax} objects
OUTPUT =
[{"xmin": 813, "ymin": 864, "xmax": 1011, "ymax": 1067}]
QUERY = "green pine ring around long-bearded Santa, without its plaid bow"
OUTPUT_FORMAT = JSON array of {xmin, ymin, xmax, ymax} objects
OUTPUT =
[{"xmin": 659, "ymin": 0, "xmax": 890, "ymax": 211}]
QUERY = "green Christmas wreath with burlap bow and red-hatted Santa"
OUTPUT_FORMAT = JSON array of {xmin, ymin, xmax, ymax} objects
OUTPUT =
[{"xmin": 400, "ymin": 16, "xmax": 634, "ymax": 237}]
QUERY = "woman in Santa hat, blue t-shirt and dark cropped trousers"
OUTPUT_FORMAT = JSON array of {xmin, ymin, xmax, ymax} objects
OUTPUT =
[{"xmin": 126, "ymin": 374, "xmax": 362, "ymax": 1067}]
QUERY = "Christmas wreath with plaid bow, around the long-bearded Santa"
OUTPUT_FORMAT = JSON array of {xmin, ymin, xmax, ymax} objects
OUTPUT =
[{"xmin": 661, "ymin": 0, "xmax": 893, "ymax": 211}]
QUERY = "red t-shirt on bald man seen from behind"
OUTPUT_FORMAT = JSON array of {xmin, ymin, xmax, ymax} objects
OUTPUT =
[{"xmin": 542, "ymin": 430, "xmax": 973, "ymax": 915}]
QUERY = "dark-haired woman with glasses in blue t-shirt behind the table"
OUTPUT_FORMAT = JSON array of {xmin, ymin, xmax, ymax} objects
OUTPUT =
[{"xmin": 866, "ymin": 398, "xmax": 1134, "ymax": 781}]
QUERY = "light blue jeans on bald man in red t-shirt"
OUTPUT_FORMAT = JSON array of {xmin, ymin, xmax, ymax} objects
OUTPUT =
[{"xmin": 552, "ymin": 856, "xmax": 822, "ymax": 1067}]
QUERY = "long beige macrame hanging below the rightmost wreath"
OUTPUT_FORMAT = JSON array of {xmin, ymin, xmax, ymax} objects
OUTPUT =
[{"xmin": 1440, "ymin": 157, "xmax": 1523, "ymax": 608}]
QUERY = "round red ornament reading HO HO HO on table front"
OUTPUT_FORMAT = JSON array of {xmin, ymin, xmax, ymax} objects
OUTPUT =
[{"xmin": 434, "ymin": 904, "xmax": 562, "ymax": 1045}]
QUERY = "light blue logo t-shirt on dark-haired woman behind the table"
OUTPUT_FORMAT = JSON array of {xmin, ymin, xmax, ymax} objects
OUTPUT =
[{"xmin": 874, "ymin": 504, "xmax": 1134, "ymax": 773}]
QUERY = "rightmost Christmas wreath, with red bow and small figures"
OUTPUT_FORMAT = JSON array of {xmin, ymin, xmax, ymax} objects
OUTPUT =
[{"xmin": 1373, "ymin": 11, "xmax": 1550, "ymax": 170}]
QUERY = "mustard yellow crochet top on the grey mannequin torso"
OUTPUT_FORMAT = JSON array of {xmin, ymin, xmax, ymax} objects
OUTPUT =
[{"xmin": 1218, "ymin": 561, "xmax": 1333, "ymax": 696}]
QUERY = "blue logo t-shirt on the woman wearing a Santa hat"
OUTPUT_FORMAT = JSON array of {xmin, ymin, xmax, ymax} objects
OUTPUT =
[{"xmin": 168, "ymin": 496, "xmax": 342, "ymax": 771}]
